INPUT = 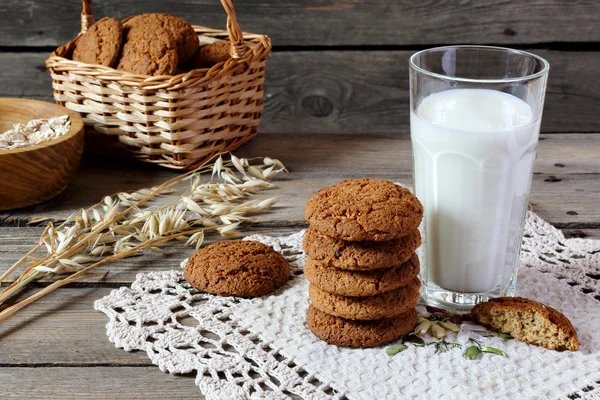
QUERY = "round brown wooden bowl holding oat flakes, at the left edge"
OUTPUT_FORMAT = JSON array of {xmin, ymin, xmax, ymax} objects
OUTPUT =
[{"xmin": 0, "ymin": 99, "xmax": 83, "ymax": 210}]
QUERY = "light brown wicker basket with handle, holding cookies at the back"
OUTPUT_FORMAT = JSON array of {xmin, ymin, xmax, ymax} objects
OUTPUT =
[{"xmin": 46, "ymin": 0, "xmax": 271, "ymax": 170}]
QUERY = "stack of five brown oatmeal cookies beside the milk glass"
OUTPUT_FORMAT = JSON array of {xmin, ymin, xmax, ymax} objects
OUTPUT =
[{"xmin": 304, "ymin": 179, "xmax": 423, "ymax": 347}]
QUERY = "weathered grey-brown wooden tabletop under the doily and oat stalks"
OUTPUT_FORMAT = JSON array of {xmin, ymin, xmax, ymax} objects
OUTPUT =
[{"xmin": 0, "ymin": 133, "xmax": 600, "ymax": 399}]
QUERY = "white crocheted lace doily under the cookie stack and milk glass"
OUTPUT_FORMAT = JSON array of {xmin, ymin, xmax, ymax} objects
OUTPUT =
[{"xmin": 95, "ymin": 213, "xmax": 600, "ymax": 400}]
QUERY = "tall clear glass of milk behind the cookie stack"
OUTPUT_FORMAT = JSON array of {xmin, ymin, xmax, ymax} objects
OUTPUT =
[{"xmin": 410, "ymin": 46, "xmax": 549, "ymax": 310}]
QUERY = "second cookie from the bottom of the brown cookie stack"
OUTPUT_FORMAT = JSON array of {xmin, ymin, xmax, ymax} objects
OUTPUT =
[{"xmin": 308, "ymin": 278, "xmax": 421, "ymax": 320}]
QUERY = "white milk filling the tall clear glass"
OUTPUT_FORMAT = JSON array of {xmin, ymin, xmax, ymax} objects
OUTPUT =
[{"xmin": 410, "ymin": 89, "xmax": 540, "ymax": 292}]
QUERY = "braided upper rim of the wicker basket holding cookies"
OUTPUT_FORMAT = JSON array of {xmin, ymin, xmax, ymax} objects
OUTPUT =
[{"xmin": 46, "ymin": 25, "xmax": 272, "ymax": 90}]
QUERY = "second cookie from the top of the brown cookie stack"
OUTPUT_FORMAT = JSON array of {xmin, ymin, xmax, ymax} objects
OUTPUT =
[{"xmin": 303, "ymin": 226, "xmax": 421, "ymax": 270}]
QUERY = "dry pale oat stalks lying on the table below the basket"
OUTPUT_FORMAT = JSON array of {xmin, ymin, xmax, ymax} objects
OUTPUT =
[{"xmin": 0, "ymin": 154, "xmax": 285, "ymax": 321}]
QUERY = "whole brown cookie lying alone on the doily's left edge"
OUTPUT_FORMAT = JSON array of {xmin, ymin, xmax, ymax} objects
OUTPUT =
[{"xmin": 183, "ymin": 240, "xmax": 290, "ymax": 297}]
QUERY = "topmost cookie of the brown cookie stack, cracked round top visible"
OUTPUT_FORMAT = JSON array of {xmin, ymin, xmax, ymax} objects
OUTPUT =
[{"xmin": 304, "ymin": 178, "xmax": 423, "ymax": 241}]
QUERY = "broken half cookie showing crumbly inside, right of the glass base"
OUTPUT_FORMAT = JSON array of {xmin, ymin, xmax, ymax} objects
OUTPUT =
[{"xmin": 471, "ymin": 297, "xmax": 579, "ymax": 351}]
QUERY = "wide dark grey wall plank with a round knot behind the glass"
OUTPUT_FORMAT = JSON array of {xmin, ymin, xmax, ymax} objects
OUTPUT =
[{"xmin": 0, "ymin": 50, "xmax": 600, "ymax": 134}]
